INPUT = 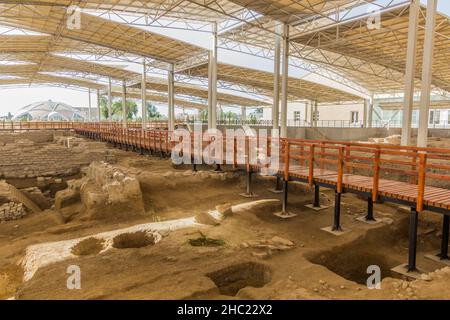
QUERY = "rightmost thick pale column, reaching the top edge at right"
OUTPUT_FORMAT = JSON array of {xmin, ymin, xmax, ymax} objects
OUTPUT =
[{"xmin": 417, "ymin": 0, "xmax": 437, "ymax": 147}]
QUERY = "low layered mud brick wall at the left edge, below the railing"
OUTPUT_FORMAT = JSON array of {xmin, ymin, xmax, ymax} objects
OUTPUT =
[{"xmin": 0, "ymin": 132, "xmax": 111, "ymax": 179}]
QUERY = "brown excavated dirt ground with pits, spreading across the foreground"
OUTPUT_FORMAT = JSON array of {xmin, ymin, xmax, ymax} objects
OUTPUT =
[{"xmin": 0, "ymin": 136, "xmax": 450, "ymax": 299}]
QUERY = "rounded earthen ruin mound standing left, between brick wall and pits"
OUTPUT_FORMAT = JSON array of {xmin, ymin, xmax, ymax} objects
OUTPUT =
[{"xmin": 55, "ymin": 162, "xmax": 145, "ymax": 220}]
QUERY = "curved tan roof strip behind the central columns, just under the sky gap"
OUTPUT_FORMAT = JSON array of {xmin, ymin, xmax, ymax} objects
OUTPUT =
[{"xmin": 184, "ymin": 63, "xmax": 362, "ymax": 103}]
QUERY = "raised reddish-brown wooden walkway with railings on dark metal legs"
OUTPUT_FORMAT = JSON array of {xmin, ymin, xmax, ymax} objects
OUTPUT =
[{"xmin": 53, "ymin": 123, "xmax": 450, "ymax": 272}]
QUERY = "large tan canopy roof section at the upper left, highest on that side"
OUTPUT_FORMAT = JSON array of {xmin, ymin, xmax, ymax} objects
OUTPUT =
[{"xmin": 0, "ymin": 4, "xmax": 205, "ymax": 63}]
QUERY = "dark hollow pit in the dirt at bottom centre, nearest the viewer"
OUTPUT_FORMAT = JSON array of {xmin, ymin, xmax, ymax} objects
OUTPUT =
[{"xmin": 207, "ymin": 262, "xmax": 272, "ymax": 296}]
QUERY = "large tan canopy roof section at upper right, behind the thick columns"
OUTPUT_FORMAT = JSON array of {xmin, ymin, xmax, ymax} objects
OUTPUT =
[{"xmin": 220, "ymin": 0, "xmax": 450, "ymax": 93}]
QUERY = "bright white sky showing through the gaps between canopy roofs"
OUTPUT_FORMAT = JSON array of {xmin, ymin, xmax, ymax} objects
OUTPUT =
[{"xmin": 0, "ymin": 0, "xmax": 450, "ymax": 116}]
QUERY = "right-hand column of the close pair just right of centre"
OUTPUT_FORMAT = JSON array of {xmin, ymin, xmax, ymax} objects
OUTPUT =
[{"xmin": 280, "ymin": 24, "xmax": 289, "ymax": 138}]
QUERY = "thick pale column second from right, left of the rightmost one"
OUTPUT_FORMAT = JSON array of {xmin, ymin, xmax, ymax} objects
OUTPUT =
[{"xmin": 401, "ymin": 0, "xmax": 420, "ymax": 146}]
